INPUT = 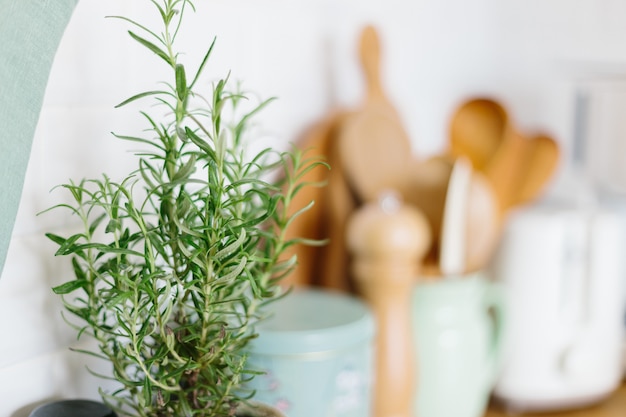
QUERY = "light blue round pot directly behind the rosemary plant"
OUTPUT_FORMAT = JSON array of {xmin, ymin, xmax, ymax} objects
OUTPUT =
[{"xmin": 249, "ymin": 289, "xmax": 374, "ymax": 417}]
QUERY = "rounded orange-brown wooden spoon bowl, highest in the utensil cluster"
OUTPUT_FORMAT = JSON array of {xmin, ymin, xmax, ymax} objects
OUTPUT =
[{"xmin": 449, "ymin": 97, "xmax": 509, "ymax": 171}]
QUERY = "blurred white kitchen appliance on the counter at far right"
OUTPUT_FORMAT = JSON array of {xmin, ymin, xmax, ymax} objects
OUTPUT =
[{"xmin": 492, "ymin": 89, "xmax": 626, "ymax": 412}]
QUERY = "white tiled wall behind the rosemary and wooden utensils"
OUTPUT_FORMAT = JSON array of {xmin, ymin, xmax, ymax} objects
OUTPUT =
[{"xmin": 0, "ymin": 0, "xmax": 626, "ymax": 417}]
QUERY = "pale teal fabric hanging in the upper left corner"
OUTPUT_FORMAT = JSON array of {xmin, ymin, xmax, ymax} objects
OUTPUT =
[{"xmin": 0, "ymin": 0, "xmax": 78, "ymax": 273}]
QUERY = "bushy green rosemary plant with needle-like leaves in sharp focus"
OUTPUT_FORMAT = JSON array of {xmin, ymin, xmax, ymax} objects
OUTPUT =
[{"xmin": 41, "ymin": 0, "xmax": 322, "ymax": 417}]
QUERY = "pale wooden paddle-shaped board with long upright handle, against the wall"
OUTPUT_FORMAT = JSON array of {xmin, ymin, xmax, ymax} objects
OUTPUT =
[{"xmin": 338, "ymin": 26, "xmax": 411, "ymax": 201}]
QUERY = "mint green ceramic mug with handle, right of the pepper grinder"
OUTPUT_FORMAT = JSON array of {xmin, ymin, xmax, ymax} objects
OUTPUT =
[{"xmin": 412, "ymin": 273, "xmax": 504, "ymax": 417}]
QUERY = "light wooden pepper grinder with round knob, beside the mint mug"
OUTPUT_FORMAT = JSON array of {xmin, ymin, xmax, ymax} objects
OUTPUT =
[{"xmin": 346, "ymin": 193, "xmax": 431, "ymax": 417}]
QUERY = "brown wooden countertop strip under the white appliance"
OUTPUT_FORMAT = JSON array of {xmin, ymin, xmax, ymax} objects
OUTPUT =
[{"xmin": 484, "ymin": 382, "xmax": 626, "ymax": 417}]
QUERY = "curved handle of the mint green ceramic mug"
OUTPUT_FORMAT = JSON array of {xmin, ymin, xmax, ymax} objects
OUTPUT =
[{"xmin": 484, "ymin": 282, "xmax": 506, "ymax": 391}]
